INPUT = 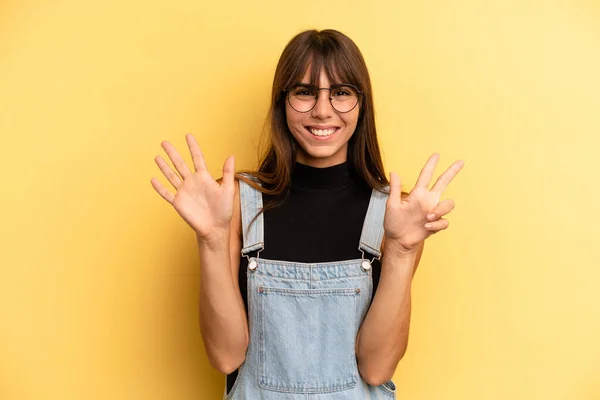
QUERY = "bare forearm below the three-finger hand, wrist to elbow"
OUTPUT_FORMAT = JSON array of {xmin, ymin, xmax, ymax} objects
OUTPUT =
[{"xmin": 356, "ymin": 246, "xmax": 417, "ymax": 385}]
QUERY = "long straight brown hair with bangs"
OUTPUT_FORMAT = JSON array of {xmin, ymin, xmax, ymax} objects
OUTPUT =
[{"xmin": 236, "ymin": 29, "xmax": 388, "ymax": 210}]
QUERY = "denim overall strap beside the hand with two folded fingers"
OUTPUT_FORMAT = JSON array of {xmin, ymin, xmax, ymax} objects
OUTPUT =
[{"xmin": 358, "ymin": 189, "xmax": 389, "ymax": 259}]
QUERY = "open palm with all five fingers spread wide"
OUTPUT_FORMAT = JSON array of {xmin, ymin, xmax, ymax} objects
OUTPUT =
[{"xmin": 150, "ymin": 133, "xmax": 235, "ymax": 242}]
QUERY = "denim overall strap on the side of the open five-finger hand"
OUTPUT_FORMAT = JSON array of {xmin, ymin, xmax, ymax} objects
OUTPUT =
[{"xmin": 239, "ymin": 174, "xmax": 265, "ymax": 256}]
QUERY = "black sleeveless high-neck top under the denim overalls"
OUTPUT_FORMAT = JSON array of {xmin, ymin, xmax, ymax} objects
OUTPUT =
[{"xmin": 227, "ymin": 162, "xmax": 381, "ymax": 393}]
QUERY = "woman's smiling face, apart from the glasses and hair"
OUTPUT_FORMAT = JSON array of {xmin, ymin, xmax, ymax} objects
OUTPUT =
[{"xmin": 285, "ymin": 67, "xmax": 360, "ymax": 168}]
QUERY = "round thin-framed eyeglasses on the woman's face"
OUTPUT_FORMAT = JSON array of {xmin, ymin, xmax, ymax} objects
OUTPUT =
[{"xmin": 284, "ymin": 83, "xmax": 363, "ymax": 113}]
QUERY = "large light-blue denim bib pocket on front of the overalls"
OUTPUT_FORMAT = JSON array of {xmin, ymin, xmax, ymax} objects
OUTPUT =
[{"xmin": 258, "ymin": 286, "xmax": 360, "ymax": 393}]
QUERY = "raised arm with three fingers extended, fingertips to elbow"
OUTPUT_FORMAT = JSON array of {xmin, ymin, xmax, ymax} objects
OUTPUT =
[{"xmin": 356, "ymin": 153, "xmax": 464, "ymax": 385}]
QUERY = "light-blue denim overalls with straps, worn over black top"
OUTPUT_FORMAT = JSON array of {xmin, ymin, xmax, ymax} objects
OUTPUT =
[{"xmin": 224, "ymin": 180, "xmax": 396, "ymax": 400}]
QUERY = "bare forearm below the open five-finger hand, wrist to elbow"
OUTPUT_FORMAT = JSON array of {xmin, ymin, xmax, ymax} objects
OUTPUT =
[{"xmin": 198, "ymin": 234, "xmax": 248, "ymax": 374}]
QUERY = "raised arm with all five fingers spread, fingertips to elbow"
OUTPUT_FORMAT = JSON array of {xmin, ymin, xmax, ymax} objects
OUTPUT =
[{"xmin": 150, "ymin": 134, "xmax": 249, "ymax": 373}]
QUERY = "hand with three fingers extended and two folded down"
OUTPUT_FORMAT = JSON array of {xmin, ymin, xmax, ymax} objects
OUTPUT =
[{"xmin": 383, "ymin": 153, "xmax": 464, "ymax": 252}]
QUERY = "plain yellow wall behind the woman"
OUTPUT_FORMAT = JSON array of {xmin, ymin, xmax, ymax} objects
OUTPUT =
[{"xmin": 0, "ymin": 0, "xmax": 600, "ymax": 400}]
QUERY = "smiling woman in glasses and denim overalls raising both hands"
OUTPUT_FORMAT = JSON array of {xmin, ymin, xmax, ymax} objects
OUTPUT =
[{"xmin": 151, "ymin": 30, "xmax": 463, "ymax": 400}]
